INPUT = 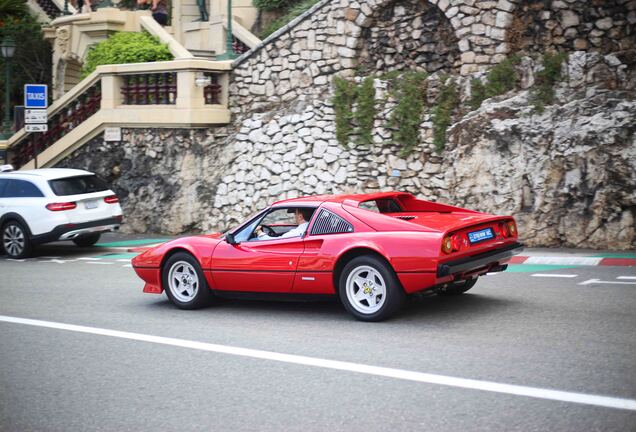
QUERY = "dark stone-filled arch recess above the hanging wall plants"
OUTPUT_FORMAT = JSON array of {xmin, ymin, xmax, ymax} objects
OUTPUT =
[{"xmin": 358, "ymin": 0, "xmax": 460, "ymax": 73}]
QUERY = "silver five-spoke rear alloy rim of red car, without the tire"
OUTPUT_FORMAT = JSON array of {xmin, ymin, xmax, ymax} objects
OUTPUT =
[{"xmin": 346, "ymin": 266, "xmax": 386, "ymax": 314}]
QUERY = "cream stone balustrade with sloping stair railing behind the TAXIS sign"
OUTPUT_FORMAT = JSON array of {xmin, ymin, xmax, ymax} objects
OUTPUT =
[{"xmin": 7, "ymin": 59, "xmax": 230, "ymax": 167}]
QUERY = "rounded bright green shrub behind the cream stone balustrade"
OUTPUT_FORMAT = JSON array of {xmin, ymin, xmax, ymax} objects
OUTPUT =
[{"xmin": 82, "ymin": 32, "xmax": 172, "ymax": 78}]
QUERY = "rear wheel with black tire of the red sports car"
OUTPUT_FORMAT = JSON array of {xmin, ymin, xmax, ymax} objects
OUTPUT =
[{"xmin": 338, "ymin": 255, "xmax": 406, "ymax": 322}]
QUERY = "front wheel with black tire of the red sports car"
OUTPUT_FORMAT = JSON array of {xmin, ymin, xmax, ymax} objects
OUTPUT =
[{"xmin": 161, "ymin": 252, "xmax": 214, "ymax": 310}]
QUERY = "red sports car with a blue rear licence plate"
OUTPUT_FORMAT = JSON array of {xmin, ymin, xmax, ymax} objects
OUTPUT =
[{"xmin": 132, "ymin": 192, "xmax": 523, "ymax": 321}]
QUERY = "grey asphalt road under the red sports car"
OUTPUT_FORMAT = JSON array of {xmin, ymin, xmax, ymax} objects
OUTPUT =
[{"xmin": 0, "ymin": 246, "xmax": 636, "ymax": 432}]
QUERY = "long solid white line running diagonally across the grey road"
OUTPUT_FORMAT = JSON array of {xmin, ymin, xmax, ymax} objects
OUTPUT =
[{"xmin": 0, "ymin": 315, "xmax": 636, "ymax": 411}]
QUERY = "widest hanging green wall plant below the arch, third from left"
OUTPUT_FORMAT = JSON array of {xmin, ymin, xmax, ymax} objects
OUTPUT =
[{"xmin": 389, "ymin": 72, "xmax": 427, "ymax": 156}]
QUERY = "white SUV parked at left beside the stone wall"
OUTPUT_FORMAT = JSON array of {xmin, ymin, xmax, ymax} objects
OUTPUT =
[{"xmin": 0, "ymin": 168, "xmax": 122, "ymax": 258}]
